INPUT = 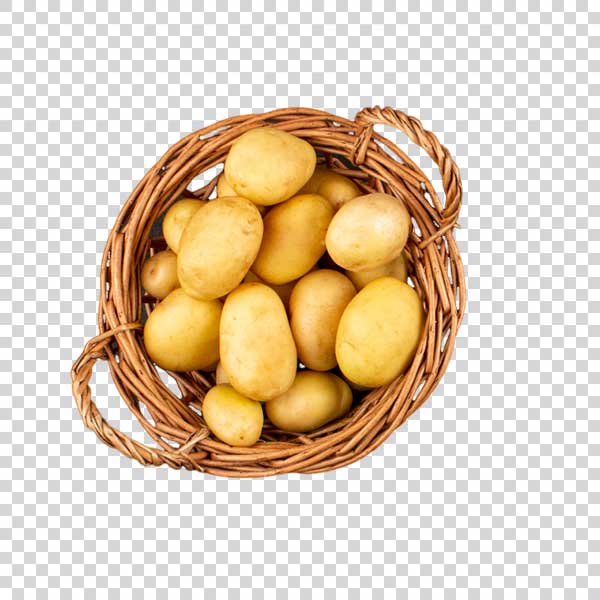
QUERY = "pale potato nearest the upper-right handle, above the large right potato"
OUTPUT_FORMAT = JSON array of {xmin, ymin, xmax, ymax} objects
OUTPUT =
[{"xmin": 326, "ymin": 193, "xmax": 410, "ymax": 271}]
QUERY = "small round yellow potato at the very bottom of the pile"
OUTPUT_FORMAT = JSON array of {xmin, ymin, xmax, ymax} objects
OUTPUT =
[{"xmin": 202, "ymin": 384, "xmax": 264, "ymax": 447}]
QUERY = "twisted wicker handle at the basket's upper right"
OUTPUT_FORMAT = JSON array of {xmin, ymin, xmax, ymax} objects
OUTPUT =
[{"xmin": 354, "ymin": 106, "xmax": 462, "ymax": 248}]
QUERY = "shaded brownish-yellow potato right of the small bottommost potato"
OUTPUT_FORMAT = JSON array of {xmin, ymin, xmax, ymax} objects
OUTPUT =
[{"xmin": 265, "ymin": 370, "xmax": 347, "ymax": 433}]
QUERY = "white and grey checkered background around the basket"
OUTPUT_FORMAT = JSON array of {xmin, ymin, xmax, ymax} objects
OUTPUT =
[{"xmin": 0, "ymin": 0, "xmax": 600, "ymax": 600}]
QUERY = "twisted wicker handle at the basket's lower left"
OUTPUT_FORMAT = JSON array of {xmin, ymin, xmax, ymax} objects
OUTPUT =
[{"xmin": 71, "ymin": 323, "xmax": 194, "ymax": 468}]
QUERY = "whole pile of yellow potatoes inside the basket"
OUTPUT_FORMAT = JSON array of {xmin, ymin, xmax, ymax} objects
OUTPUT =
[{"xmin": 142, "ymin": 127, "xmax": 425, "ymax": 446}]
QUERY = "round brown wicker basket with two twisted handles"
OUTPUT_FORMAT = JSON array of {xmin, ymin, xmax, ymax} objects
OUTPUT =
[{"xmin": 71, "ymin": 107, "xmax": 465, "ymax": 477}]
